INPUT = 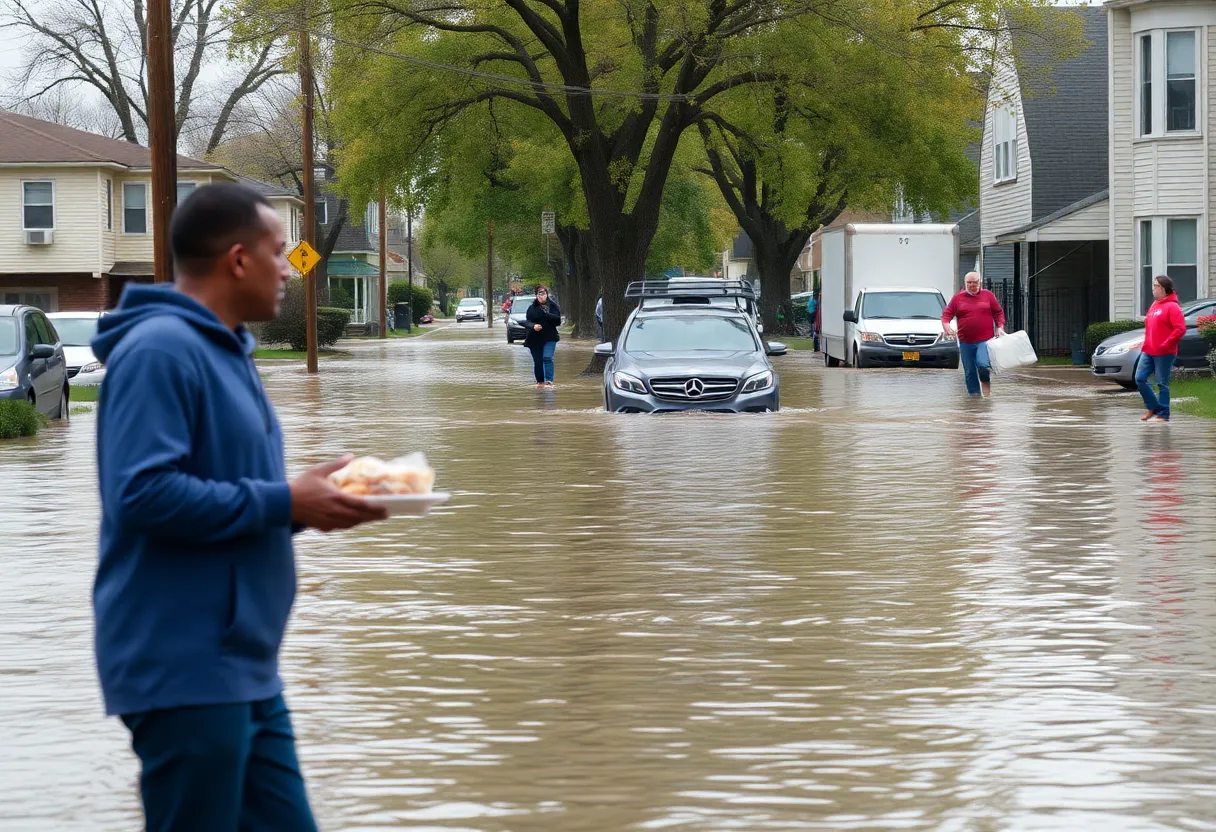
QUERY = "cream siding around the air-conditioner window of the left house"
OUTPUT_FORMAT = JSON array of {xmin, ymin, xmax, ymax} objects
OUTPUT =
[{"xmin": 0, "ymin": 168, "xmax": 98, "ymax": 274}]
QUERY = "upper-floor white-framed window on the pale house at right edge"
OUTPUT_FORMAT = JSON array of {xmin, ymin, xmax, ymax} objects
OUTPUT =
[{"xmin": 1136, "ymin": 29, "xmax": 1199, "ymax": 136}]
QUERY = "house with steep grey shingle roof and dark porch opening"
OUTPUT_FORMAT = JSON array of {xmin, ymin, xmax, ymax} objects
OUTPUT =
[{"xmin": 979, "ymin": 7, "xmax": 1110, "ymax": 354}]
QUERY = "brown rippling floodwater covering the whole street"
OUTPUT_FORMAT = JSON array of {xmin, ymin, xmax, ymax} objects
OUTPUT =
[{"xmin": 0, "ymin": 324, "xmax": 1216, "ymax": 832}]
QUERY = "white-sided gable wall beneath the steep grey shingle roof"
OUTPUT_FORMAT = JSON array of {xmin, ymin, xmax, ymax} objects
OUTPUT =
[{"xmin": 980, "ymin": 29, "xmax": 1032, "ymax": 246}]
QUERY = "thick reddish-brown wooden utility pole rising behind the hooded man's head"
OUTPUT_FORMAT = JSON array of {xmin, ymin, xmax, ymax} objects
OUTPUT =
[{"xmin": 147, "ymin": 0, "xmax": 178, "ymax": 283}]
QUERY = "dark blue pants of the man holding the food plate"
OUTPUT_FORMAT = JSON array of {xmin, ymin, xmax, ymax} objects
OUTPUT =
[{"xmin": 123, "ymin": 696, "xmax": 316, "ymax": 832}]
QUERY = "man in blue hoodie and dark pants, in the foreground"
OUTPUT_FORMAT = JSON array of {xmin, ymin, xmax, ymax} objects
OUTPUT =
[{"xmin": 92, "ymin": 185, "xmax": 383, "ymax": 832}]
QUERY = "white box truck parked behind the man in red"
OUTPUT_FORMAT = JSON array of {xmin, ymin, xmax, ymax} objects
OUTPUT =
[{"xmin": 820, "ymin": 223, "xmax": 959, "ymax": 369}]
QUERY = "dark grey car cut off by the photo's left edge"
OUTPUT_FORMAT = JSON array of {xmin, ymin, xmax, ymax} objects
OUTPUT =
[{"xmin": 0, "ymin": 305, "xmax": 69, "ymax": 418}]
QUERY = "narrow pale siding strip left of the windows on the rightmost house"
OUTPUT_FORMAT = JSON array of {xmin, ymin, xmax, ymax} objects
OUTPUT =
[{"xmin": 1107, "ymin": 9, "xmax": 1136, "ymax": 319}]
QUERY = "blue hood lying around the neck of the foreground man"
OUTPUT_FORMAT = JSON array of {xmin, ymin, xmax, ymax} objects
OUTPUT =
[{"xmin": 91, "ymin": 283, "xmax": 257, "ymax": 362}]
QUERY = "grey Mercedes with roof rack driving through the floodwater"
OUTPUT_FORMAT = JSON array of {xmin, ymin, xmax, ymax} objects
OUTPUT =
[{"xmin": 596, "ymin": 281, "xmax": 786, "ymax": 414}]
